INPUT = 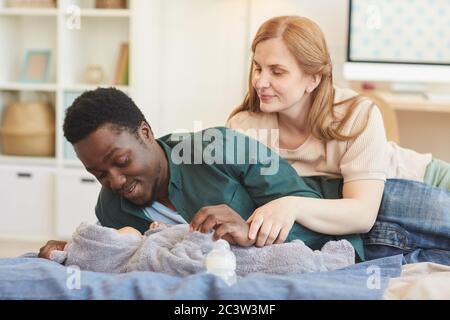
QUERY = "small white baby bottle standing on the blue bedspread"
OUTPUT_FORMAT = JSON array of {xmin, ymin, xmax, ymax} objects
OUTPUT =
[{"xmin": 206, "ymin": 239, "xmax": 236, "ymax": 286}]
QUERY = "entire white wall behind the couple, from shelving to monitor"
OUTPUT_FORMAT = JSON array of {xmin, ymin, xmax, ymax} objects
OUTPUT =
[{"xmin": 134, "ymin": 0, "xmax": 347, "ymax": 136}]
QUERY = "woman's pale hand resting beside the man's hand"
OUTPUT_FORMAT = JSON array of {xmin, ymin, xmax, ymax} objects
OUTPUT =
[{"xmin": 247, "ymin": 197, "xmax": 298, "ymax": 247}]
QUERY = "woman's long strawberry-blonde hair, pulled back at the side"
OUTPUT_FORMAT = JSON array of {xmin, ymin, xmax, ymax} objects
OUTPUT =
[{"xmin": 229, "ymin": 16, "xmax": 370, "ymax": 141}]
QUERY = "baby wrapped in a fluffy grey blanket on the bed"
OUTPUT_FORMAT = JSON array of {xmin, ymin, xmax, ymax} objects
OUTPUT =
[{"xmin": 50, "ymin": 223, "xmax": 355, "ymax": 276}]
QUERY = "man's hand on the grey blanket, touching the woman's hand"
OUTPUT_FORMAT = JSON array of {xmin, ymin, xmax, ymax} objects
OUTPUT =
[{"xmin": 190, "ymin": 204, "xmax": 255, "ymax": 247}]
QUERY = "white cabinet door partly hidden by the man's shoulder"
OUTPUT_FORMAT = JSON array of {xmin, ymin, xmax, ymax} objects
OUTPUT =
[{"xmin": 56, "ymin": 170, "xmax": 101, "ymax": 238}]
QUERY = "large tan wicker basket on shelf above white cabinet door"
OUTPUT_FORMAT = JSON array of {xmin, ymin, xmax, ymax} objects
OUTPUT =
[{"xmin": 0, "ymin": 102, "xmax": 55, "ymax": 157}]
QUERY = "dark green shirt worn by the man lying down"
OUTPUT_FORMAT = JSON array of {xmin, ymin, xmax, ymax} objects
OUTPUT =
[{"xmin": 95, "ymin": 127, "xmax": 364, "ymax": 259}]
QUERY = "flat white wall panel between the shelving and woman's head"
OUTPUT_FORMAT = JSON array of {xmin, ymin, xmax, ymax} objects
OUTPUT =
[{"xmin": 160, "ymin": 0, "xmax": 248, "ymax": 133}]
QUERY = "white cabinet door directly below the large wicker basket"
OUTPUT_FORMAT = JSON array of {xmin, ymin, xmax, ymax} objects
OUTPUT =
[{"xmin": 0, "ymin": 166, "xmax": 54, "ymax": 239}]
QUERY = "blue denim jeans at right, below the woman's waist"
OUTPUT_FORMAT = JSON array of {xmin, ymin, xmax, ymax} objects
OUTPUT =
[{"xmin": 363, "ymin": 179, "xmax": 450, "ymax": 265}]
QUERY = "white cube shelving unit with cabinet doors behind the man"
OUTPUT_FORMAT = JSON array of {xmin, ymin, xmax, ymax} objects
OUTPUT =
[{"xmin": 0, "ymin": 0, "xmax": 135, "ymax": 241}]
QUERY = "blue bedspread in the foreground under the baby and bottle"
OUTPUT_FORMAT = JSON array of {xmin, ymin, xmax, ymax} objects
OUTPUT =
[{"xmin": 0, "ymin": 255, "xmax": 402, "ymax": 300}]
